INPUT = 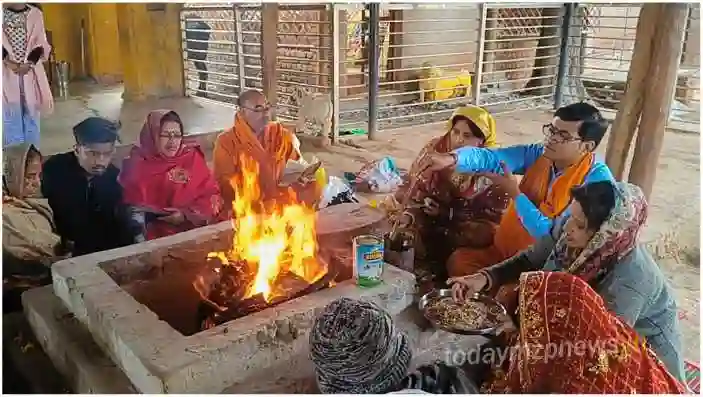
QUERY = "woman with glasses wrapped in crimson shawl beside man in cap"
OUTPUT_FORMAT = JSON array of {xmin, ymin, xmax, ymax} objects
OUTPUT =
[{"xmin": 120, "ymin": 110, "xmax": 222, "ymax": 240}]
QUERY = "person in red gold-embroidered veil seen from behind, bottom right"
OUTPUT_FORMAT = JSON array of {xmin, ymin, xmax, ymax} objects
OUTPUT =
[{"xmin": 481, "ymin": 271, "xmax": 686, "ymax": 394}]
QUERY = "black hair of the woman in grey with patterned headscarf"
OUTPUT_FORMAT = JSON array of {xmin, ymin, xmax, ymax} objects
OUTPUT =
[{"xmin": 571, "ymin": 181, "xmax": 615, "ymax": 230}]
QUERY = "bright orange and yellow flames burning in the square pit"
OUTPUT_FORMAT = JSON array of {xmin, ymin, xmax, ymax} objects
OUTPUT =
[{"xmin": 208, "ymin": 156, "xmax": 327, "ymax": 302}]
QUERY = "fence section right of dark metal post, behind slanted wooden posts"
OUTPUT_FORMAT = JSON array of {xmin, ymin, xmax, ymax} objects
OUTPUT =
[{"xmin": 565, "ymin": 3, "xmax": 700, "ymax": 132}]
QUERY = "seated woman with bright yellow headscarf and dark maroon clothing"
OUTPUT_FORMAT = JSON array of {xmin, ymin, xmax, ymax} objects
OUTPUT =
[{"xmin": 396, "ymin": 106, "xmax": 511, "ymax": 279}]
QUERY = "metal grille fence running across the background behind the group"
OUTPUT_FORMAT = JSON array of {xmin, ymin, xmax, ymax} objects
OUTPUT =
[{"xmin": 181, "ymin": 3, "xmax": 700, "ymax": 139}]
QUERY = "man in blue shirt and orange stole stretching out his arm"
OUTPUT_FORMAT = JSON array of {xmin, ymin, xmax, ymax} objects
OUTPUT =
[{"xmin": 423, "ymin": 102, "xmax": 613, "ymax": 277}]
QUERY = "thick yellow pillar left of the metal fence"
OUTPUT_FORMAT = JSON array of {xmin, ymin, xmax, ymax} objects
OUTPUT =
[{"xmin": 116, "ymin": 3, "xmax": 184, "ymax": 100}]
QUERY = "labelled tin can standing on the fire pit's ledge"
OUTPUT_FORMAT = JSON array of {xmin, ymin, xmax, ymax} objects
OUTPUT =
[{"xmin": 353, "ymin": 235, "xmax": 384, "ymax": 287}]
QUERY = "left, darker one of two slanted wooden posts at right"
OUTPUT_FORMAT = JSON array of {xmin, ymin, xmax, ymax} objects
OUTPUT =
[{"xmin": 605, "ymin": 3, "xmax": 663, "ymax": 180}]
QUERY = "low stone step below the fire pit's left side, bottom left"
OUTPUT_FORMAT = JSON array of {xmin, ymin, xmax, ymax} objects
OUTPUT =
[{"xmin": 22, "ymin": 285, "xmax": 136, "ymax": 394}]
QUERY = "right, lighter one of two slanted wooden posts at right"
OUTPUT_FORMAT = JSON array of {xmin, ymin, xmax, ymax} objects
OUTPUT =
[{"xmin": 628, "ymin": 3, "xmax": 689, "ymax": 197}]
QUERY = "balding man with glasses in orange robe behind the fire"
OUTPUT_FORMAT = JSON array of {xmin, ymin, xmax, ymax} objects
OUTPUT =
[{"xmin": 213, "ymin": 90, "xmax": 319, "ymax": 206}]
